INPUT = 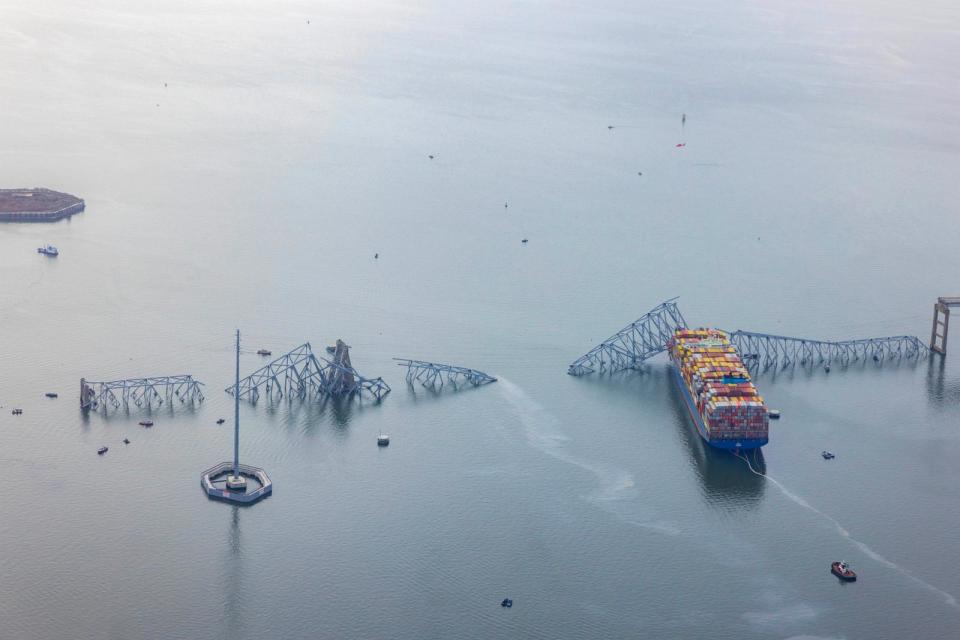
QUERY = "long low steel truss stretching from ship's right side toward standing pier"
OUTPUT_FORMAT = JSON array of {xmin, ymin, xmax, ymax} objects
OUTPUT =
[{"xmin": 730, "ymin": 331, "xmax": 929, "ymax": 371}]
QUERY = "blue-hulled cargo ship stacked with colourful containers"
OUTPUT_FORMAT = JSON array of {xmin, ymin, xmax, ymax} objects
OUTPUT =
[{"xmin": 667, "ymin": 329, "xmax": 770, "ymax": 451}]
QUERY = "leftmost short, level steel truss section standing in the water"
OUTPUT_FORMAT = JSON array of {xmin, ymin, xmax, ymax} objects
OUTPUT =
[{"xmin": 80, "ymin": 375, "xmax": 203, "ymax": 409}]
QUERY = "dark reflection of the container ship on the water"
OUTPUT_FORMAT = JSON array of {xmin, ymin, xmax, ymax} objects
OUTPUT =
[{"xmin": 664, "ymin": 372, "xmax": 766, "ymax": 508}]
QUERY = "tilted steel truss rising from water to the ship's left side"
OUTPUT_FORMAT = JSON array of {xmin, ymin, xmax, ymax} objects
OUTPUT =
[{"xmin": 567, "ymin": 298, "xmax": 687, "ymax": 376}]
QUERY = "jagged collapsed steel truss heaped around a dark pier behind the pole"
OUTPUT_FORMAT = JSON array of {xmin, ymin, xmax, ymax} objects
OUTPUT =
[{"xmin": 225, "ymin": 340, "xmax": 390, "ymax": 402}]
